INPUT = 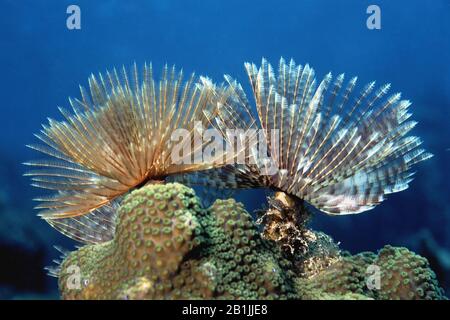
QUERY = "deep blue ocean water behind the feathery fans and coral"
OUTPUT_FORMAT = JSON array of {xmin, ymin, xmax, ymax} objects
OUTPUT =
[{"xmin": 0, "ymin": 0, "xmax": 450, "ymax": 298}]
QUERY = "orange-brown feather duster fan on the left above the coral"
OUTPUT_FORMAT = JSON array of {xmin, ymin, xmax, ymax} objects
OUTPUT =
[{"xmin": 25, "ymin": 65, "xmax": 221, "ymax": 243}]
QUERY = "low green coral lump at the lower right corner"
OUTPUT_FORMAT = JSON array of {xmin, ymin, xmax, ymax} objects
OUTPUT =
[{"xmin": 297, "ymin": 246, "xmax": 446, "ymax": 300}]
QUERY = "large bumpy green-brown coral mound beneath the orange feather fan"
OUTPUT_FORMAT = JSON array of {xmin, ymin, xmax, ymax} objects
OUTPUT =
[{"xmin": 59, "ymin": 183, "xmax": 295, "ymax": 299}]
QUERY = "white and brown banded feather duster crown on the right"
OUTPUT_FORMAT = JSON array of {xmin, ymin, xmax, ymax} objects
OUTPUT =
[{"xmin": 195, "ymin": 58, "xmax": 432, "ymax": 215}]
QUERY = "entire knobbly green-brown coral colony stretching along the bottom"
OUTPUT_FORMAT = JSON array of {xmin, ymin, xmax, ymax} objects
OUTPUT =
[{"xmin": 59, "ymin": 183, "xmax": 443, "ymax": 299}]
